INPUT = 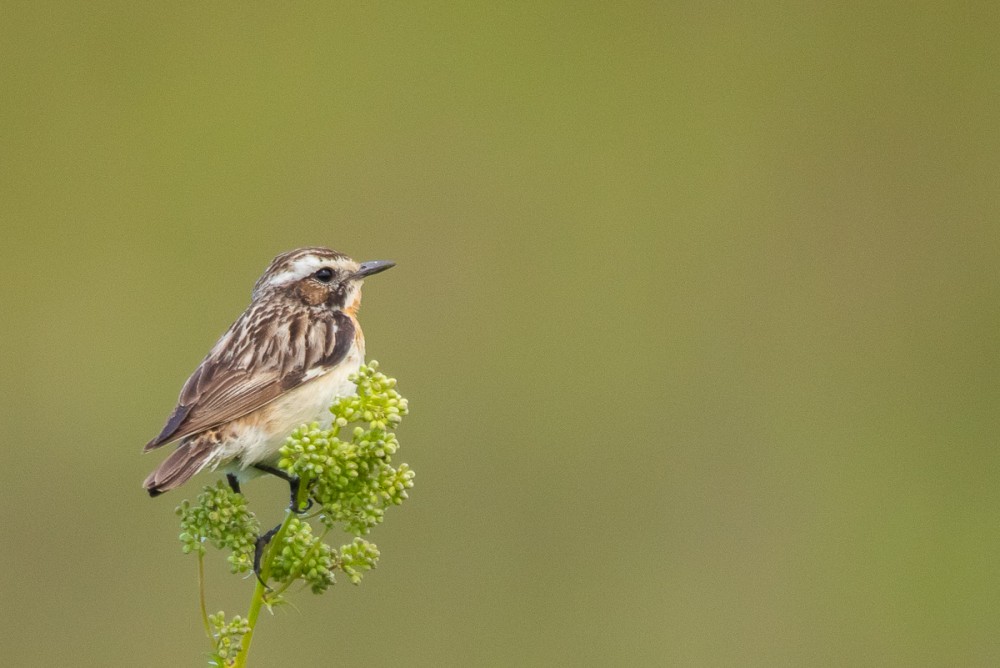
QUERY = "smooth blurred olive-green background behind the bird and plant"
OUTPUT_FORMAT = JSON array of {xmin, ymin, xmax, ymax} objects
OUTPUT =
[{"xmin": 0, "ymin": 2, "xmax": 1000, "ymax": 666}]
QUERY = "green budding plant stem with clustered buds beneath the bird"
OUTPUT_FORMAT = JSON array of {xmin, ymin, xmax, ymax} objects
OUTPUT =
[{"xmin": 176, "ymin": 361, "xmax": 414, "ymax": 668}]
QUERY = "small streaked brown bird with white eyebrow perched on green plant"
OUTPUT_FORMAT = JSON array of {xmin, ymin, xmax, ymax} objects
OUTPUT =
[{"xmin": 143, "ymin": 247, "xmax": 394, "ymax": 499}]
